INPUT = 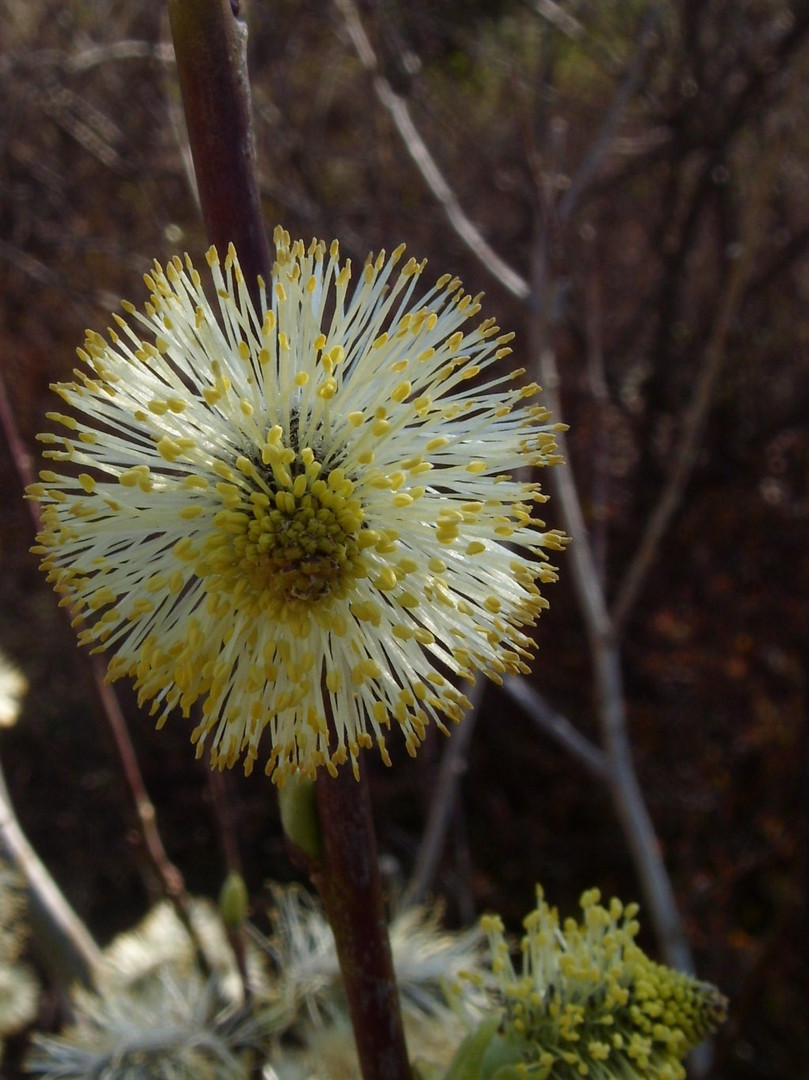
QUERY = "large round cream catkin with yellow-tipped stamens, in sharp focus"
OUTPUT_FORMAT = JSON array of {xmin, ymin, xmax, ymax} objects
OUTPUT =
[{"xmin": 29, "ymin": 229, "xmax": 565, "ymax": 783}]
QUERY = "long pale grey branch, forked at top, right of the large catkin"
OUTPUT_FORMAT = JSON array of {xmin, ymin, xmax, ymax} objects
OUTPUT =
[{"xmin": 335, "ymin": 0, "xmax": 764, "ymax": 989}]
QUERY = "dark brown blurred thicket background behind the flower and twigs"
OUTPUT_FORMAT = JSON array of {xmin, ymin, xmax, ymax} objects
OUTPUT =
[{"xmin": 0, "ymin": 0, "xmax": 809, "ymax": 1080}]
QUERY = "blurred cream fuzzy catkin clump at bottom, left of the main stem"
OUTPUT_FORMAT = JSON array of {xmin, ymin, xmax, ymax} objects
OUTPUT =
[{"xmin": 26, "ymin": 902, "xmax": 267, "ymax": 1080}]
